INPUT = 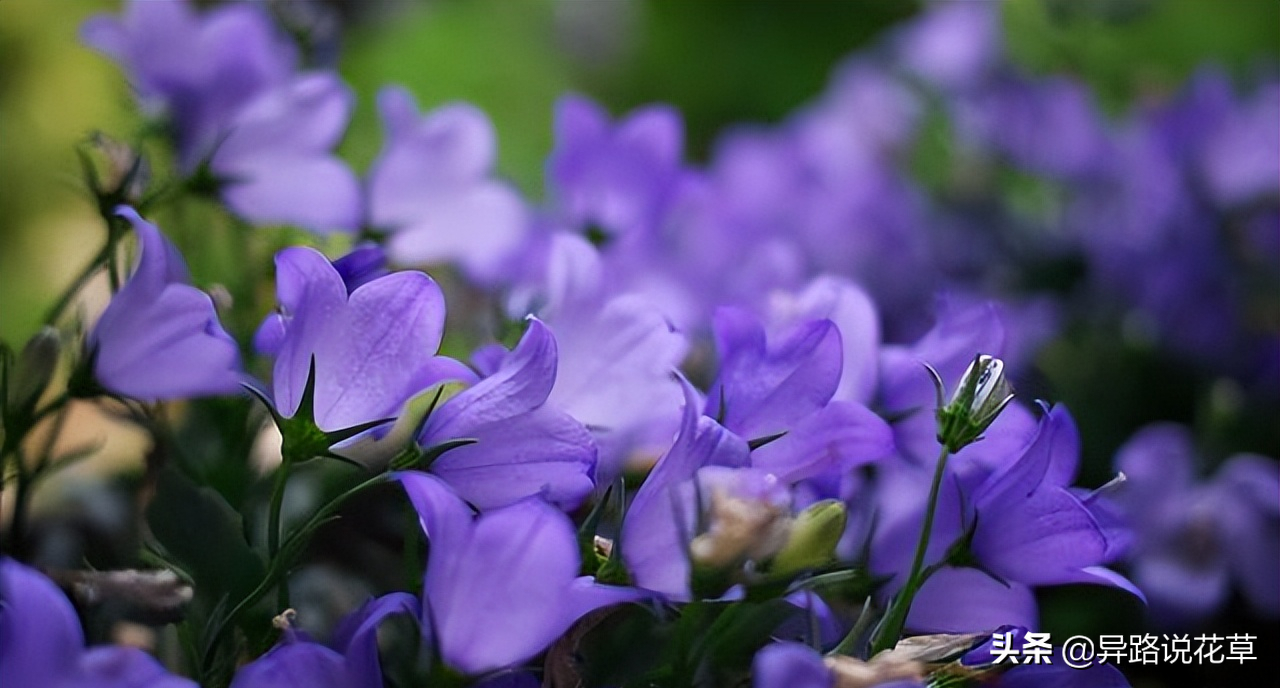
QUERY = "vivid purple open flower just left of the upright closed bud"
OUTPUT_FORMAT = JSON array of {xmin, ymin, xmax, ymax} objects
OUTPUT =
[{"xmin": 704, "ymin": 308, "xmax": 892, "ymax": 483}]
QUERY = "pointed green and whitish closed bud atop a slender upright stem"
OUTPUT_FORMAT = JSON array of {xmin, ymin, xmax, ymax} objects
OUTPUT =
[{"xmin": 929, "ymin": 354, "xmax": 1014, "ymax": 451}]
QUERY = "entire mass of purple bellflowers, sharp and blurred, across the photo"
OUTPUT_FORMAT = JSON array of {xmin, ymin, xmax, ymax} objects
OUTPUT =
[{"xmin": 0, "ymin": 0, "xmax": 1280, "ymax": 688}]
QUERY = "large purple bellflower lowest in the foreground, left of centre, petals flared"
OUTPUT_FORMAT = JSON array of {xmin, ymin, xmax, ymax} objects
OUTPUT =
[{"xmin": 399, "ymin": 473, "xmax": 639, "ymax": 675}]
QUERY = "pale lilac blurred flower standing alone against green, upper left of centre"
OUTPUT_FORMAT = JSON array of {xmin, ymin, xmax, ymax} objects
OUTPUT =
[{"xmin": 369, "ymin": 88, "xmax": 529, "ymax": 280}]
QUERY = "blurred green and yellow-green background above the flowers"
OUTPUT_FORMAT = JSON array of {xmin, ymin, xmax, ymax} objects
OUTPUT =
[{"xmin": 0, "ymin": 0, "xmax": 1280, "ymax": 343}]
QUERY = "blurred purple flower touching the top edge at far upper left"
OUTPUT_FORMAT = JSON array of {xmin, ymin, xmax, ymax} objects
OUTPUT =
[{"xmin": 81, "ymin": 0, "xmax": 297, "ymax": 173}]
